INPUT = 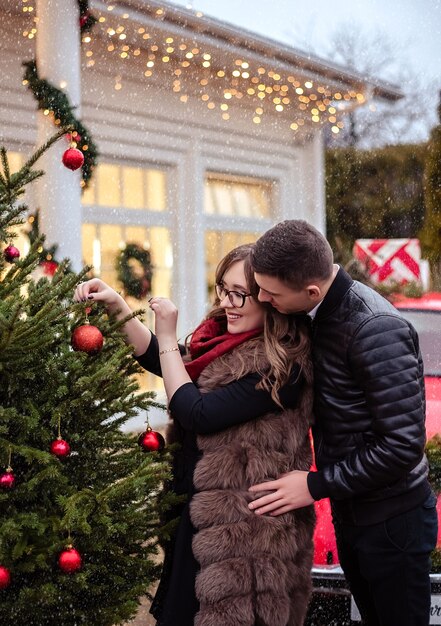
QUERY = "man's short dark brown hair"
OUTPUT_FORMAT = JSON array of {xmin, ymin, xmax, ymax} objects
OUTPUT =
[{"xmin": 251, "ymin": 220, "xmax": 334, "ymax": 290}]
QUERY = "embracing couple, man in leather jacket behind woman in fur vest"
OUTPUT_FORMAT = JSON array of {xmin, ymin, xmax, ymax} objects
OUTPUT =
[{"xmin": 75, "ymin": 220, "xmax": 437, "ymax": 626}]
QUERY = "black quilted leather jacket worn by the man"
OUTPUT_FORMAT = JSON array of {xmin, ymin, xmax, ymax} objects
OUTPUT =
[{"xmin": 308, "ymin": 268, "xmax": 430, "ymax": 525}]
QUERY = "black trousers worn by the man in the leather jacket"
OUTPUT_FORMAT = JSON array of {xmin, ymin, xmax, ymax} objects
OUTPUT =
[{"xmin": 334, "ymin": 494, "xmax": 438, "ymax": 626}]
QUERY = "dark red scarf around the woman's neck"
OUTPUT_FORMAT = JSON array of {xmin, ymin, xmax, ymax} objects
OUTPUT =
[{"xmin": 185, "ymin": 318, "xmax": 262, "ymax": 381}]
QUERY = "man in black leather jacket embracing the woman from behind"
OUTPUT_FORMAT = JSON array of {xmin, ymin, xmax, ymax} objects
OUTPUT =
[{"xmin": 249, "ymin": 220, "xmax": 437, "ymax": 626}]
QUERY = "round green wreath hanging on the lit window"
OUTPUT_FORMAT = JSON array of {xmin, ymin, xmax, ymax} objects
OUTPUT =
[{"xmin": 116, "ymin": 243, "xmax": 153, "ymax": 300}]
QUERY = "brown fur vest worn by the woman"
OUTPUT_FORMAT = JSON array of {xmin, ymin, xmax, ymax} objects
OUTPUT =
[{"xmin": 190, "ymin": 338, "xmax": 314, "ymax": 626}]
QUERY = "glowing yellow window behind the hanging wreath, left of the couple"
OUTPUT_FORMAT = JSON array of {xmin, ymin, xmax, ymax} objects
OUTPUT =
[{"xmin": 82, "ymin": 163, "xmax": 173, "ymax": 390}]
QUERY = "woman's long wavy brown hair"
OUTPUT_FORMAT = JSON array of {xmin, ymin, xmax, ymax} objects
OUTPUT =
[{"xmin": 207, "ymin": 244, "xmax": 312, "ymax": 407}]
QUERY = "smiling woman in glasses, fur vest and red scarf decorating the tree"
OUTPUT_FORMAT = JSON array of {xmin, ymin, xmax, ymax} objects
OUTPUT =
[{"xmin": 76, "ymin": 245, "xmax": 314, "ymax": 626}]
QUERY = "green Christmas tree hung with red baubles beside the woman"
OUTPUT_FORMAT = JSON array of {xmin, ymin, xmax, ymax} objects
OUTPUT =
[{"xmin": 0, "ymin": 131, "xmax": 169, "ymax": 626}]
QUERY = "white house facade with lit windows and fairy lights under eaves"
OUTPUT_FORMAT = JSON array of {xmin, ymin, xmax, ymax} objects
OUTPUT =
[{"xmin": 0, "ymin": 0, "xmax": 399, "ymax": 334}]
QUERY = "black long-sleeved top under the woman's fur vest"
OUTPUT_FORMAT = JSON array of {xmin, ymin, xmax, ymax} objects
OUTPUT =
[{"xmin": 137, "ymin": 334, "xmax": 302, "ymax": 434}]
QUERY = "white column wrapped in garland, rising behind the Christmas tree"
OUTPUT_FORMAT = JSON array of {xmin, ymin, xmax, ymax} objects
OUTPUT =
[{"xmin": 36, "ymin": 0, "xmax": 82, "ymax": 271}]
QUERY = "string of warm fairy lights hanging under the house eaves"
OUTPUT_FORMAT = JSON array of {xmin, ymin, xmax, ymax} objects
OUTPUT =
[{"xmin": 18, "ymin": 0, "xmax": 365, "ymax": 134}]
